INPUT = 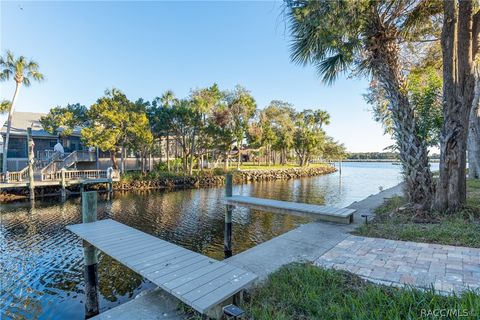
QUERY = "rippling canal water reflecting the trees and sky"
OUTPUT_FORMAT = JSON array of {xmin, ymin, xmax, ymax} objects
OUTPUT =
[{"xmin": 0, "ymin": 163, "xmax": 414, "ymax": 319}]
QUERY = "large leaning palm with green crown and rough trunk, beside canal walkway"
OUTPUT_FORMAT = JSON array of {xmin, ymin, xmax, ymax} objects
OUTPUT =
[{"xmin": 286, "ymin": 0, "xmax": 441, "ymax": 209}]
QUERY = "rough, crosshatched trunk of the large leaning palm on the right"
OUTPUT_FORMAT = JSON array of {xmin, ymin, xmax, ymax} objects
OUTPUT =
[{"xmin": 369, "ymin": 19, "xmax": 436, "ymax": 210}]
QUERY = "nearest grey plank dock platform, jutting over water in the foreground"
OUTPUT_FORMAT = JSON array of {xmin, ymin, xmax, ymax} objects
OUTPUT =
[{"xmin": 67, "ymin": 219, "xmax": 257, "ymax": 313}]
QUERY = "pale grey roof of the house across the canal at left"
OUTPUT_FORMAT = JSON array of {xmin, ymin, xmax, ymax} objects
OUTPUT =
[{"xmin": 0, "ymin": 112, "xmax": 80, "ymax": 138}]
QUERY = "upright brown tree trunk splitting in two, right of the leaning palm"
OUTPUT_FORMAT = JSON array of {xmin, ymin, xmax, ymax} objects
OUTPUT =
[{"xmin": 433, "ymin": 1, "xmax": 478, "ymax": 212}]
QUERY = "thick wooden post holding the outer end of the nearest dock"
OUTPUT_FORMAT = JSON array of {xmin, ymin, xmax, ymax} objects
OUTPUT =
[{"xmin": 82, "ymin": 191, "xmax": 99, "ymax": 319}]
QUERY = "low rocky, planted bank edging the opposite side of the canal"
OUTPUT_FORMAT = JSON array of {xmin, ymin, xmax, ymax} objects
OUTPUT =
[{"xmin": 0, "ymin": 163, "xmax": 337, "ymax": 203}]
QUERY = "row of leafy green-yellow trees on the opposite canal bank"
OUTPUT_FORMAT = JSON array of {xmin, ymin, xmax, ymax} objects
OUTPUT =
[{"xmin": 40, "ymin": 84, "xmax": 345, "ymax": 174}]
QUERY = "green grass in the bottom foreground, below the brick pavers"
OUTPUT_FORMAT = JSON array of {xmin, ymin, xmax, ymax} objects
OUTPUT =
[{"xmin": 243, "ymin": 264, "xmax": 480, "ymax": 320}]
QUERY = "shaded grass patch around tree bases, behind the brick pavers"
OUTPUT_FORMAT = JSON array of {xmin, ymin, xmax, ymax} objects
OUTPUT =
[{"xmin": 354, "ymin": 180, "xmax": 480, "ymax": 248}]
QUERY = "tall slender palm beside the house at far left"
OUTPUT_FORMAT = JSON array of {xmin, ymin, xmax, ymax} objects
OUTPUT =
[{"xmin": 0, "ymin": 51, "xmax": 43, "ymax": 173}]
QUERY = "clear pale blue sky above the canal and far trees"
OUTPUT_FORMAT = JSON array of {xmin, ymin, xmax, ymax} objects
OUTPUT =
[{"xmin": 0, "ymin": 1, "xmax": 392, "ymax": 151}]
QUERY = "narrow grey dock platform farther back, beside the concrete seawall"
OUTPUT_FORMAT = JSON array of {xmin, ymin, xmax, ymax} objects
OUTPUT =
[{"xmin": 225, "ymin": 196, "xmax": 356, "ymax": 223}]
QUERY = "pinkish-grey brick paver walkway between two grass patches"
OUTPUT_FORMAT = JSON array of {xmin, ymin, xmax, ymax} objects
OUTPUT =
[{"xmin": 315, "ymin": 236, "xmax": 480, "ymax": 293}]
